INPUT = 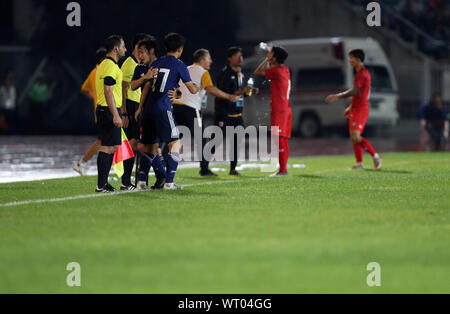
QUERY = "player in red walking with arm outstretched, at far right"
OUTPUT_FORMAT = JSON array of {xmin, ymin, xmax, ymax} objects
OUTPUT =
[{"xmin": 325, "ymin": 49, "xmax": 382, "ymax": 170}]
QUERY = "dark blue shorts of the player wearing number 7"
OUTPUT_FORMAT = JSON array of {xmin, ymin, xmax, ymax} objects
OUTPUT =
[{"xmin": 141, "ymin": 110, "xmax": 180, "ymax": 145}]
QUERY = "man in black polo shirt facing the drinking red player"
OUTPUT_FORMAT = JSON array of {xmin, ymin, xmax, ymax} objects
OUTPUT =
[{"xmin": 215, "ymin": 47, "xmax": 259, "ymax": 175}]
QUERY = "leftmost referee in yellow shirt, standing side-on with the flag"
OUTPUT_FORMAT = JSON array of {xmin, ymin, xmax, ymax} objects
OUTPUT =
[{"xmin": 95, "ymin": 35, "xmax": 127, "ymax": 193}]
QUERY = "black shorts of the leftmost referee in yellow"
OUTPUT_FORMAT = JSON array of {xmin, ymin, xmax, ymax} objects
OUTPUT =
[{"xmin": 97, "ymin": 106, "xmax": 122, "ymax": 146}]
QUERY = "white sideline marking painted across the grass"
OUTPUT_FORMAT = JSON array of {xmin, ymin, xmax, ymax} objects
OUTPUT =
[{"xmin": 0, "ymin": 159, "xmax": 449, "ymax": 207}]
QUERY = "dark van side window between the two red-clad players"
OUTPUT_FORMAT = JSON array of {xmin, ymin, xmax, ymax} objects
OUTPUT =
[{"xmin": 296, "ymin": 68, "xmax": 345, "ymax": 90}]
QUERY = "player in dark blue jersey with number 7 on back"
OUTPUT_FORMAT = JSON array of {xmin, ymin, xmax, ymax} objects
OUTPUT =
[{"xmin": 137, "ymin": 33, "xmax": 199, "ymax": 190}]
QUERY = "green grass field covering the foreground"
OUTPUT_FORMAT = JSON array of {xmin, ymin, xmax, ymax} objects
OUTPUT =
[{"xmin": 0, "ymin": 153, "xmax": 450, "ymax": 293}]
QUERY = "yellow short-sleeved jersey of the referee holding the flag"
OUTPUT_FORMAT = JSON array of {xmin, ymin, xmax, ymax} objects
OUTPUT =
[{"xmin": 95, "ymin": 57, "xmax": 123, "ymax": 108}]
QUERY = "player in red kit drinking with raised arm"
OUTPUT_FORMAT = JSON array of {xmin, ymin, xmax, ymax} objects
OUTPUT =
[{"xmin": 254, "ymin": 47, "xmax": 292, "ymax": 176}]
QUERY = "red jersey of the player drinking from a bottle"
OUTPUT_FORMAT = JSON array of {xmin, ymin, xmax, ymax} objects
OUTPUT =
[{"xmin": 265, "ymin": 65, "xmax": 291, "ymax": 112}]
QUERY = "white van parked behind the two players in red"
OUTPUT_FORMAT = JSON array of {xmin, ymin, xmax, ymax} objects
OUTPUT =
[{"xmin": 243, "ymin": 37, "xmax": 399, "ymax": 138}]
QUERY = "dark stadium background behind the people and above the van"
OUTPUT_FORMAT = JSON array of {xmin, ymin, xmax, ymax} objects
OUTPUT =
[{"xmin": 0, "ymin": 0, "xmax": 450, "ymax": 135}]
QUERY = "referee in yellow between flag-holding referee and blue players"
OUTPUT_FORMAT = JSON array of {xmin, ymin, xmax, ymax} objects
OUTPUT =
[{"xmin": 120, "ymin": 33, "xmax": 154, "ymax": 191}]
